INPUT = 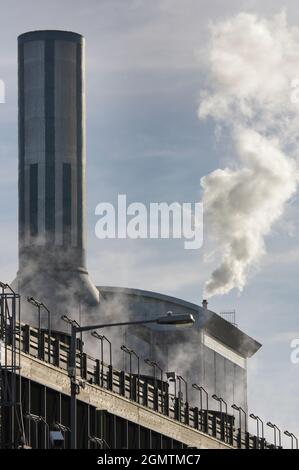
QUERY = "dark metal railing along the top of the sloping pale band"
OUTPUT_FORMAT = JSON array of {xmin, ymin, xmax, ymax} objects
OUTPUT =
[{"xmin": 2, "ymin": 325, "xmax": 282, "ymax": 449}]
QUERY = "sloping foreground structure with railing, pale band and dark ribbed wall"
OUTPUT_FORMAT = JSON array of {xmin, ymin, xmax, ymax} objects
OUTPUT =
[{"xmin": 0, "ymin": 285, "xmax": 273, "ymax": 449}]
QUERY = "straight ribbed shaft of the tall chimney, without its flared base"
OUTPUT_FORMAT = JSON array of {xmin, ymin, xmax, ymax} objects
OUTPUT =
[{"xmin": 19, "ymin": 31, "xmax": 85, "ymax": 252}]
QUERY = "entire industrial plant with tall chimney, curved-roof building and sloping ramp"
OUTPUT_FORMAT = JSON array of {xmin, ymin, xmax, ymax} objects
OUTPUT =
[{"xmin": 0, "ymin": 31, "xmax": 293, "ymax": 449}]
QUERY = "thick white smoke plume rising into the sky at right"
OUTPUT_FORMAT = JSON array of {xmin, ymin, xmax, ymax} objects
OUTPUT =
[{"xmin": 198, "ymin": 12, "xmax": 299, "ymax": 297}]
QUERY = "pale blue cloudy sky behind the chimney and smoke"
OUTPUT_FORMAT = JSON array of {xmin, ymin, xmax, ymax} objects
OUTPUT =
[{"xmin": 0, "ymin": 0, "xmax": 299, "ymax": 446}]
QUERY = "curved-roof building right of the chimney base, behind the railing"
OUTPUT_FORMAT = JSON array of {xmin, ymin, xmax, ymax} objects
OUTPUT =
[{"xmin": 99, "ymin": 286, "xmax": 261, "ymax": 410}]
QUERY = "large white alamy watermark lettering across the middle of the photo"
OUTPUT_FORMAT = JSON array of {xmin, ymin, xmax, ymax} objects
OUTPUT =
[{"xmin": 95, "ymin": 194, "xmax": 203, "ymax": 250}]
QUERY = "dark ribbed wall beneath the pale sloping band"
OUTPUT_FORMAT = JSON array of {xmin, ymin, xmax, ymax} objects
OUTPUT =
[{"xmin": 4, "ymin": 377, "xmax": 186, "ymax": 449}]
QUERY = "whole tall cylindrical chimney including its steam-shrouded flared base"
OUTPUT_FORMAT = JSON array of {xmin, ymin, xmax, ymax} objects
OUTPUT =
[{"xmin": 17, "ymin": 31, "xmax": 99, "ymax": 326}]
